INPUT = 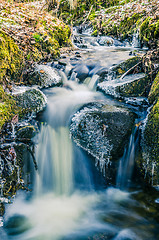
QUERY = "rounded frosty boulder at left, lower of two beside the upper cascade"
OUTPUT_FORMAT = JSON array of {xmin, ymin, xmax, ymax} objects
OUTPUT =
[{"xmin": 14, "ymin": 89, "xmax": 47, "ymax": 117}]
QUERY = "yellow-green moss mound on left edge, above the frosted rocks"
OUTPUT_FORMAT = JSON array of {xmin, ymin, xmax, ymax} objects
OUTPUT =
[{"xmin": 0, "ymin": 29, "xmax": 23, "ymax": 83}]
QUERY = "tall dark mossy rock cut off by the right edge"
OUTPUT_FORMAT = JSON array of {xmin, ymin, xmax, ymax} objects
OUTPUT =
[{"xmin": 142, "ymin": 74, "xmax": 159, "ymax": 185}]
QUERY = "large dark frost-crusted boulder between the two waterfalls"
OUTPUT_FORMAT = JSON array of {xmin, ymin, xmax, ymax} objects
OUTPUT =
[{"xmin": 70, "ymin": 103, "xmax": 134, "ymax": 171}]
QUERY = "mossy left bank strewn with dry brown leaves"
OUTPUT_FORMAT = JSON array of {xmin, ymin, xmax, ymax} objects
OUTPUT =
[{"xmin": 0, "ymin": 0, "xmax": 71, "ymax": 129}]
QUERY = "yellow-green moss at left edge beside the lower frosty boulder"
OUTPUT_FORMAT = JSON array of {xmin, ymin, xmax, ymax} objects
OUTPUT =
[{"xmin": 0, "ymin": 87, "xmax": 20, "ymax": 129}]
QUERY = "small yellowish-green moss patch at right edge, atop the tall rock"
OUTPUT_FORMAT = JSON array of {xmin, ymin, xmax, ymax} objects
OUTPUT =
[{"xmin": 148, "ymin": 73, "xmax": 159, "ymax": 103}]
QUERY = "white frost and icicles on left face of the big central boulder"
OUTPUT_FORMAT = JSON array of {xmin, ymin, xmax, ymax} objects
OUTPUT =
[{"xmin": 70, "ymin": 107, "xmax": 113, "ymax": 174}]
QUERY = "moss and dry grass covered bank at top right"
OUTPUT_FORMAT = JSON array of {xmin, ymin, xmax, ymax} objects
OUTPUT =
[{"xmin": 47, "ymin": 0, "xmax": 159, "ymax": 48}]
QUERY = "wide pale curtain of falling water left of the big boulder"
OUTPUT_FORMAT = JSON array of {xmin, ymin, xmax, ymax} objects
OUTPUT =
[{"xmin": 35, "ymin": 125, "xmax": 73, "ymax": 195}]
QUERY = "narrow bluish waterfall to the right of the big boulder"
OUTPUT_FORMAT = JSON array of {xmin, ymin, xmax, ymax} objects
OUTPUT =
[{"xmin": 116, "ymin": 127, "xmax": 138, "ymax": 189}]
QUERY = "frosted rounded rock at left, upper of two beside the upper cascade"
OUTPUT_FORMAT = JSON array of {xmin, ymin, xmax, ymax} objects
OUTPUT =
[{"xmin": 24, "ymin": 64, "xmax": 62, "ymax": 88}]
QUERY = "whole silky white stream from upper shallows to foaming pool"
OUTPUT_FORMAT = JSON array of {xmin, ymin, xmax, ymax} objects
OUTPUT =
[{"xmin": 0, "ymin": 29, "xmax": 159, "ymax": 240}]
